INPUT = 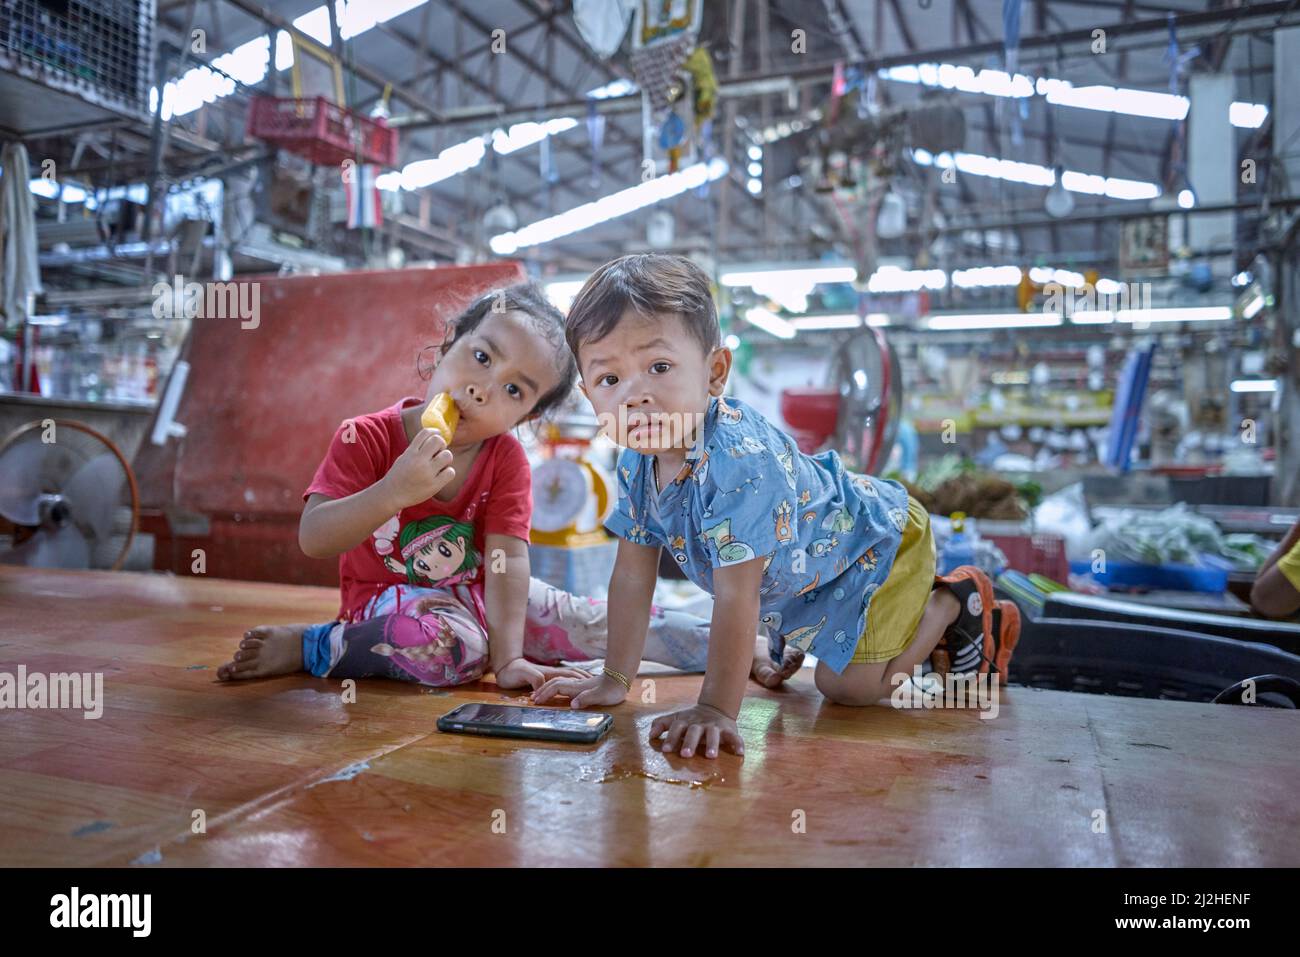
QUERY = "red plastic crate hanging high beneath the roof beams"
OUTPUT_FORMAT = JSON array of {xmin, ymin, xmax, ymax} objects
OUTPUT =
[{"xmin": 248, "ymin": 96, "xmax": 398, "ymax": 166}]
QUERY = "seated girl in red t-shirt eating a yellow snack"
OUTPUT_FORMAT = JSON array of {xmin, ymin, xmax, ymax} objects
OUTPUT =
[{"xmin": 217, "ymin": 283, "xmax": 709, "ymax": 688}]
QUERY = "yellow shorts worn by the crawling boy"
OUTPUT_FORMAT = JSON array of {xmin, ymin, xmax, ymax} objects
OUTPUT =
[{"xmin": 849, "ymin": 495, "xmax": 935, "ymax": 664}]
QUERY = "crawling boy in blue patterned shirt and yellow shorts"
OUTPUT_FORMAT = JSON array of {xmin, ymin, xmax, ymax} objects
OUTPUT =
[{"xmin": 533, "ymin": 255, "xmax": 1019, "ymax": 758}]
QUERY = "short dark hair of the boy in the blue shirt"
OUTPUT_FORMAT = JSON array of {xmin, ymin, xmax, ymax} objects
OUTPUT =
[{"xmin": 564, "ymin": 252, "xmax": 722, "ymax": 355}]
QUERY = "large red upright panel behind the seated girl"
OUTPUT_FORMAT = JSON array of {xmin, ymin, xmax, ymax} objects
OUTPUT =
[{"xmin": 133, "ymin": 263, "xmax": 524, "ymax": 585}]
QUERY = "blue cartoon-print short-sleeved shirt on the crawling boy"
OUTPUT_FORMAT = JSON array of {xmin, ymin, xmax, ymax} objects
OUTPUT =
[{"xmin": 605, "ymin": 398, "xmax": 907, "ymax": 672}]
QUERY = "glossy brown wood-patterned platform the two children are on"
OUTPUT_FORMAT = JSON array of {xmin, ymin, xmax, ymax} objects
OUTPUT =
[{"xmin": 0, "ymin": 568, "xmax": 1300, "ymax": 866}]
